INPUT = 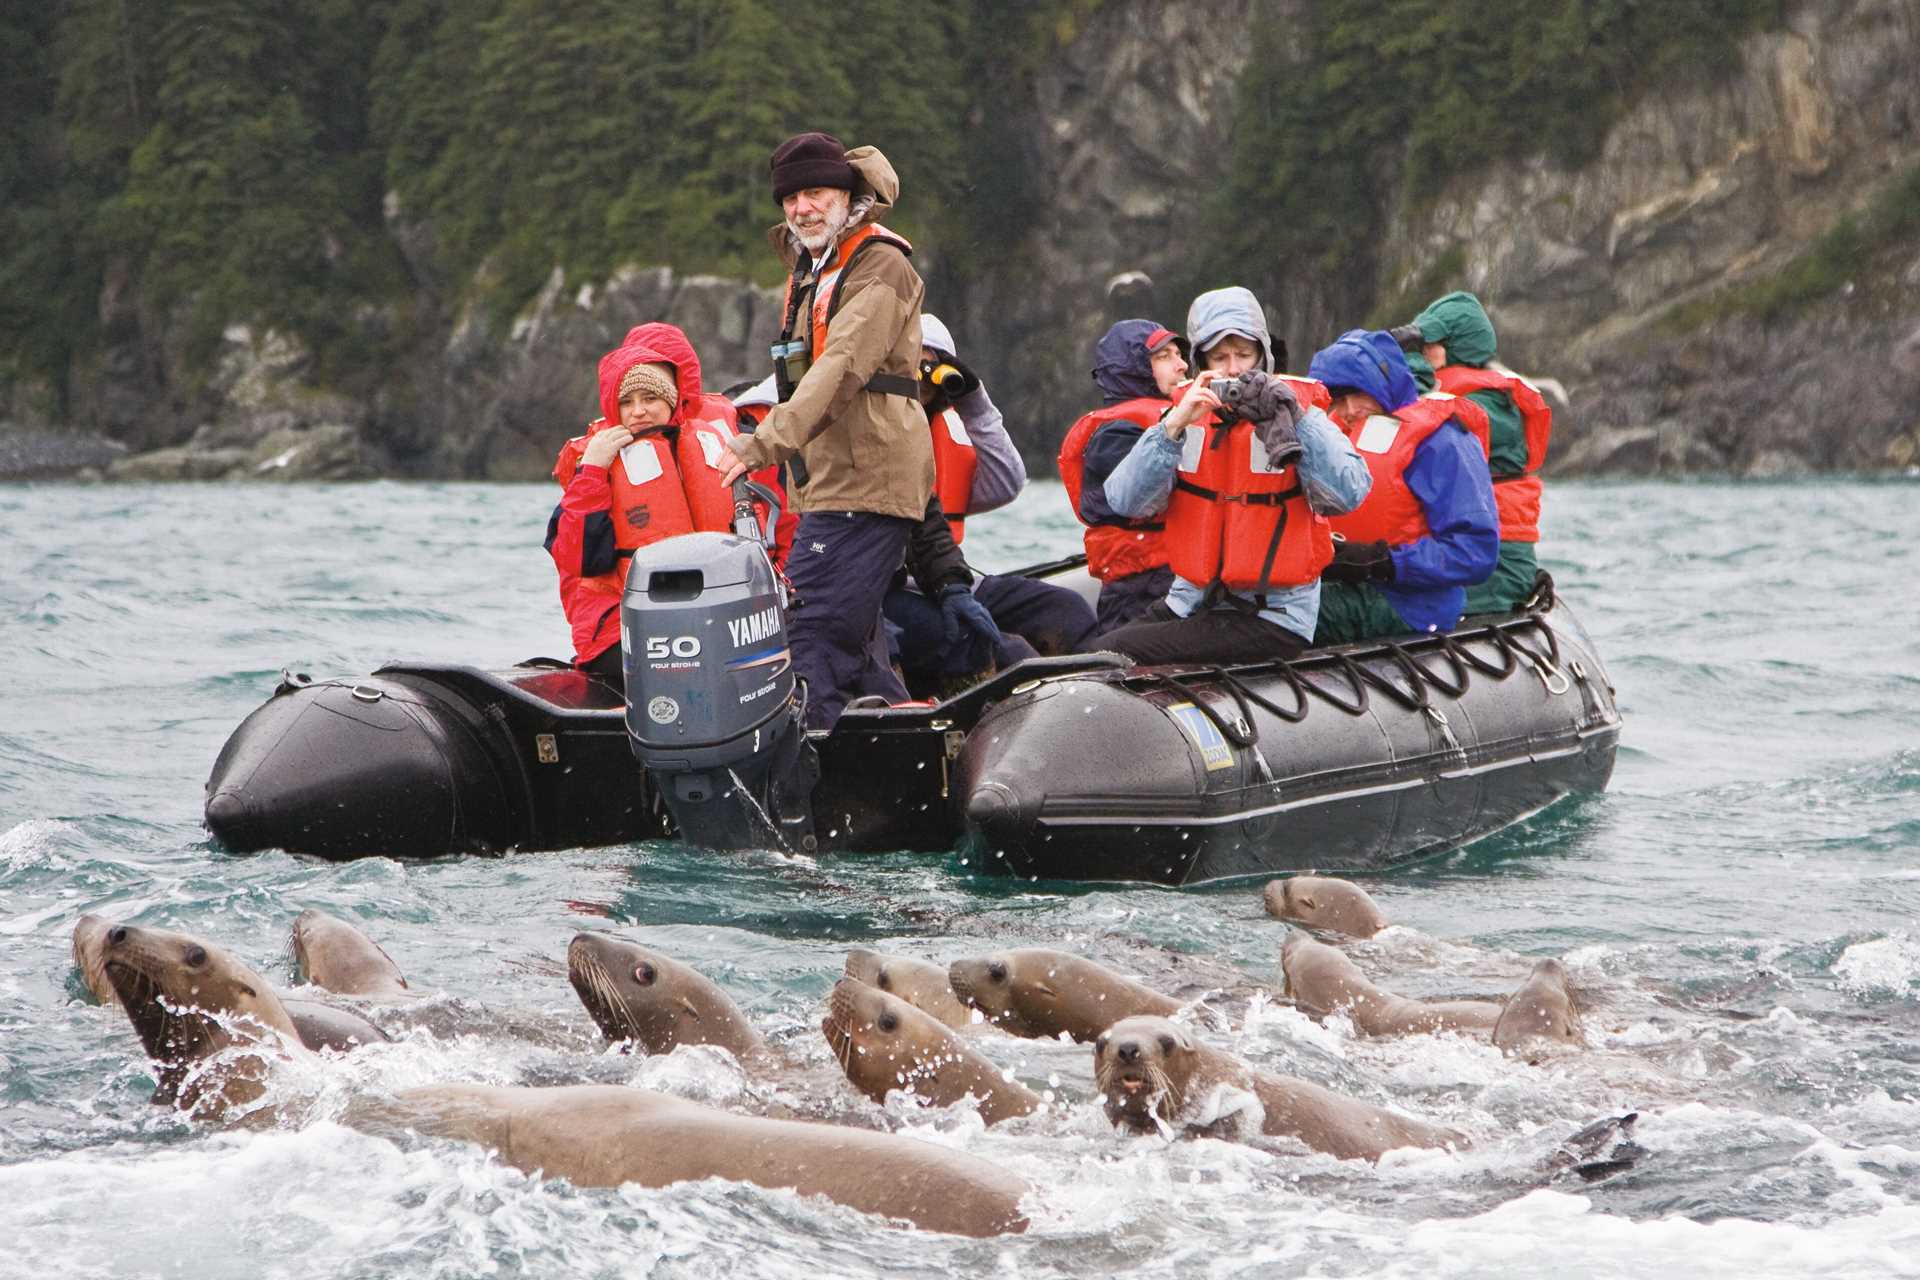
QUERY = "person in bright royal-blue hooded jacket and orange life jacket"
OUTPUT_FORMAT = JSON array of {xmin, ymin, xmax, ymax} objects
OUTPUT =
[{"xmin": 1308, "ymin": 328, "xmax": 1500, "ymax": 645}]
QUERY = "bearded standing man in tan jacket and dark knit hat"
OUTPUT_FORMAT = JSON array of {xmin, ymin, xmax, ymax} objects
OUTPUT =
[{"xmin": 724, "ymin": 132, "xmax": 933, "ymax": 729}]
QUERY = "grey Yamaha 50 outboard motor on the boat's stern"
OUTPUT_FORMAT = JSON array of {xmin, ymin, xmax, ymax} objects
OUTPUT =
[{"xmin": 620, "ymin": 486, "xmax": 820, "ymax": 852}]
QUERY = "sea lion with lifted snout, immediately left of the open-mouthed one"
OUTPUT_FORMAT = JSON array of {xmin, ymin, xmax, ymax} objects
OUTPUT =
[{"xmin": 820, "ymin": 979, "xmax": 1041, "ymax": 1125}]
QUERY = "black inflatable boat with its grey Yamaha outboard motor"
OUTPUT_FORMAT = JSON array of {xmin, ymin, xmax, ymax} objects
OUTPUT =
[{"xmin": 205, "ymin": 533, "xmax": 1620, "ymax": 885}]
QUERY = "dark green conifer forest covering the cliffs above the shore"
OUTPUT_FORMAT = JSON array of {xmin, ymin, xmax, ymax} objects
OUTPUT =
[{"xmin": 11, "ymin": 0, "xmax": 1780, "ymax": 420}]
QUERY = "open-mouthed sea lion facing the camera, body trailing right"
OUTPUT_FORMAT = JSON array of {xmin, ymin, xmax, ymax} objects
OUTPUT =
[{"xmin": 1092, "ymin": 1017, "xmax": 1465, "ymax": 1161}]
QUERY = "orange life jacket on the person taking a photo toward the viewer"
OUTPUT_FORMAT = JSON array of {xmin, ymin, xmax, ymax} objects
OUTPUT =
[{"xmin": 1165, "ymin": 378, "xmax": 1332, "ymax": 593}]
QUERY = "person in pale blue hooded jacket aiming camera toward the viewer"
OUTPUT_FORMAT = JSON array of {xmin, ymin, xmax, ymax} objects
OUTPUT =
[{"xmin": 1098, "ymin": 288, "xmax": 1371, "ymax": 662}]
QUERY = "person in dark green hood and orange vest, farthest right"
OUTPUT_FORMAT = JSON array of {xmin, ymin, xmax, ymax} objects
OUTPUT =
[{"xmin": 1394, "ymin": 290, "xmax": 1553, "ymax": 614}]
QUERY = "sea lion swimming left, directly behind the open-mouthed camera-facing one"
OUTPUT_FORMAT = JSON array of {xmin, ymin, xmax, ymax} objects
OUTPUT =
[{"xmin": 947, "ymin": 946, "xmax": 1181, "ymax": 1044}]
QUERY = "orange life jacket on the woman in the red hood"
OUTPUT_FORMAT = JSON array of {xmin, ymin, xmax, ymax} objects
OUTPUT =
[{"xmin": 553, "ymin": 393, "xmax": 735, "ymax": 599}]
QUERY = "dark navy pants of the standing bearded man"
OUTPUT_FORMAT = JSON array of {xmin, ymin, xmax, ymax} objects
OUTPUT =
[{"xmin": 787, "ymin": 510, "xmax": 920, "ymax": 729}]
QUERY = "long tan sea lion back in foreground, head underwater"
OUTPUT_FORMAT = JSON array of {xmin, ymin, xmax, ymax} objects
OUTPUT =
[{"xmin": 348, "ymin": 1084, "xmax": 1027, "ymax": 1236}]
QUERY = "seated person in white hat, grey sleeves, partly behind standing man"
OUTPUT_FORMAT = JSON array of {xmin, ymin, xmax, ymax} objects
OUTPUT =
[{"xmin": 883, "ymin": 311, "xmax": 1094, "ymax": 689}]
